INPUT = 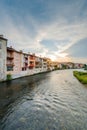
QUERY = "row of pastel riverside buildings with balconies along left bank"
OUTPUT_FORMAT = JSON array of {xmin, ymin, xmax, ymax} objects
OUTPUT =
[{"xmin": 0, "ymin": 36, "xmax": 53, "ymax": 81}]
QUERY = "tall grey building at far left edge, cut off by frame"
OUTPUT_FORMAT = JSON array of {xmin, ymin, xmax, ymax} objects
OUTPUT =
[{"xmin": 0, "ymin": 35, "xmax": 7, "ymax": 81}]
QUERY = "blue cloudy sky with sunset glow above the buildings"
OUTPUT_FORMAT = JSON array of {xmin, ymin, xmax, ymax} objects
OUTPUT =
[{"xmin": 0, "ymin": 0, "xmax": 87, "ymax": 63}]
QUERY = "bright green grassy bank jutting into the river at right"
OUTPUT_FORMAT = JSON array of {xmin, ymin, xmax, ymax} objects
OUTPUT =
[{"xmin": 73, "ymin": 71, "xmax": 87, "ymax": 84}]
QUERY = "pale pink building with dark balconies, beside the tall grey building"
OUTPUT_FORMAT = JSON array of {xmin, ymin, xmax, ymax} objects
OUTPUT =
[{"xmin": 7, "ymin": 47, "xmax": 22, "ymax": 74}]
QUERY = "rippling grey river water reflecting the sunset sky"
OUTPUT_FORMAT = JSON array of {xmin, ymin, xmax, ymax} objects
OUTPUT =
[{"xmin": 0, "ymin": 70, "xmax": 87, "ymax": 130}]
